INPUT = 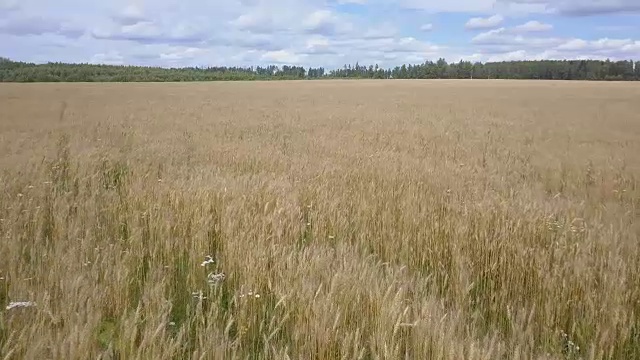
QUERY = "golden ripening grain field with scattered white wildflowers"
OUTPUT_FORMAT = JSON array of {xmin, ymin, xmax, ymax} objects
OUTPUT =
[{"xmin": 0, "ymin": 80, "xmax": 640, "ymax": 359}]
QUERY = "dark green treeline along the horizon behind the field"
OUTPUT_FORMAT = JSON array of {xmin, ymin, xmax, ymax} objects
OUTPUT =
[{"xmin": 0, "ymin": 58, "xmax": 640, "ymax": 82}]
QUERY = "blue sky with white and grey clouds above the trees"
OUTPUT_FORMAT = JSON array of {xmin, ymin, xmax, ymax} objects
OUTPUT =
[{"xmin": 0, "ymin": 0, "xmax": 640, "ymax": 69}]
